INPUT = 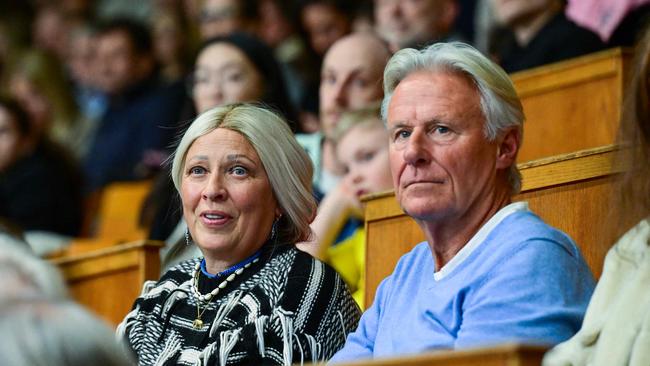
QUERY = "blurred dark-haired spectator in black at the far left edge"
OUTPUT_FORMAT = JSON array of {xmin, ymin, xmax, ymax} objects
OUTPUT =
[{"xmin": 0, "ymin": 98, "xmax": 82, "ymax": 236}]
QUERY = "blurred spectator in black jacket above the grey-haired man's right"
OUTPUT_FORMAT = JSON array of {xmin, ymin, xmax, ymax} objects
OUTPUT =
[{"xmin": 492, "ymin": 0, "xmax": 605, "ymax": 72}]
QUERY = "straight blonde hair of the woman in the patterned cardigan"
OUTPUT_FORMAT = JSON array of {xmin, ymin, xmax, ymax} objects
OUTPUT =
[{"xmin": 171, "ymin": 103, "xmax": 316, "ymax": 243}]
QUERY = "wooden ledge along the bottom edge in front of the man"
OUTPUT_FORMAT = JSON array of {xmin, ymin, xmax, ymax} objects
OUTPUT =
[{"xmin": 330, "ymin": 344, "xmax": 547, "ymax": 366}]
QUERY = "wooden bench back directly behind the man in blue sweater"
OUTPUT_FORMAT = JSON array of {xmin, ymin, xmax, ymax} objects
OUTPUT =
[{"xmin": 364, "ymin": 146, "xmax": 626, "ymax": 304}]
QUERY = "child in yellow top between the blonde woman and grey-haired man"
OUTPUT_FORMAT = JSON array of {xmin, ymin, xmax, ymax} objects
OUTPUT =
[{"xmin": 299, "ymin": 108, "xmax": 393, "ymax": 309}]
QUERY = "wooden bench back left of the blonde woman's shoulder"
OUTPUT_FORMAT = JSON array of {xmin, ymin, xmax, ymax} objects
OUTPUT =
[{"xmin": 51, "ymin": 241, "xmax": 162, "ymax": 325}]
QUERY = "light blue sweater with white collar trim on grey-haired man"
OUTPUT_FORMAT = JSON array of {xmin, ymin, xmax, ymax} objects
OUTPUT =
[{"xmin": 331, "ymin": 203, "xmax": 595, "ymax": 362}]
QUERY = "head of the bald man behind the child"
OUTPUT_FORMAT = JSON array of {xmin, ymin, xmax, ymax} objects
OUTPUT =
[{"xmin": 320, "ymin": 33, "xmax": 390, "ymax": 135}]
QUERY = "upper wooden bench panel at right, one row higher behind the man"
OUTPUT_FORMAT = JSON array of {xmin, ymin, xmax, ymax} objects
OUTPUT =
[{"xmin": 511, "ymin": 49, "xmax": 630, "ymax": 162}]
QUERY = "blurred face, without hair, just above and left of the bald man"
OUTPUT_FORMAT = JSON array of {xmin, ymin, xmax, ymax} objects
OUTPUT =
[{"xmin": 302, "ymin": 3, "xmax": 350, "ymax": 55}]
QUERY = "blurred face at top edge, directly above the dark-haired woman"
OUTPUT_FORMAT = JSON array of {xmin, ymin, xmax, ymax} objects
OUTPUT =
[{"xmin": 198, "ymin": 0, "xmax": 259, "ymax": 40}]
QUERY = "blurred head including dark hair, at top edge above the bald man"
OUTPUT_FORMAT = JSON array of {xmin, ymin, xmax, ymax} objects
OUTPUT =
[{"xmin": 300, "ymin": 0, "xmax": 354, "ymax": 57}]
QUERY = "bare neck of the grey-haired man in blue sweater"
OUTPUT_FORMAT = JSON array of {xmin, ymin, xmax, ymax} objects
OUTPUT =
[{"xmin": 418, "ymin": 189, "xmax": 511, "ymax": 271}]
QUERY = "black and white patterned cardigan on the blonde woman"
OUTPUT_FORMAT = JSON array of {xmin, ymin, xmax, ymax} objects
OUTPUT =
[{"xmin": 117, "ymin": 246, "xmax": 360, "ymax": 365}]
